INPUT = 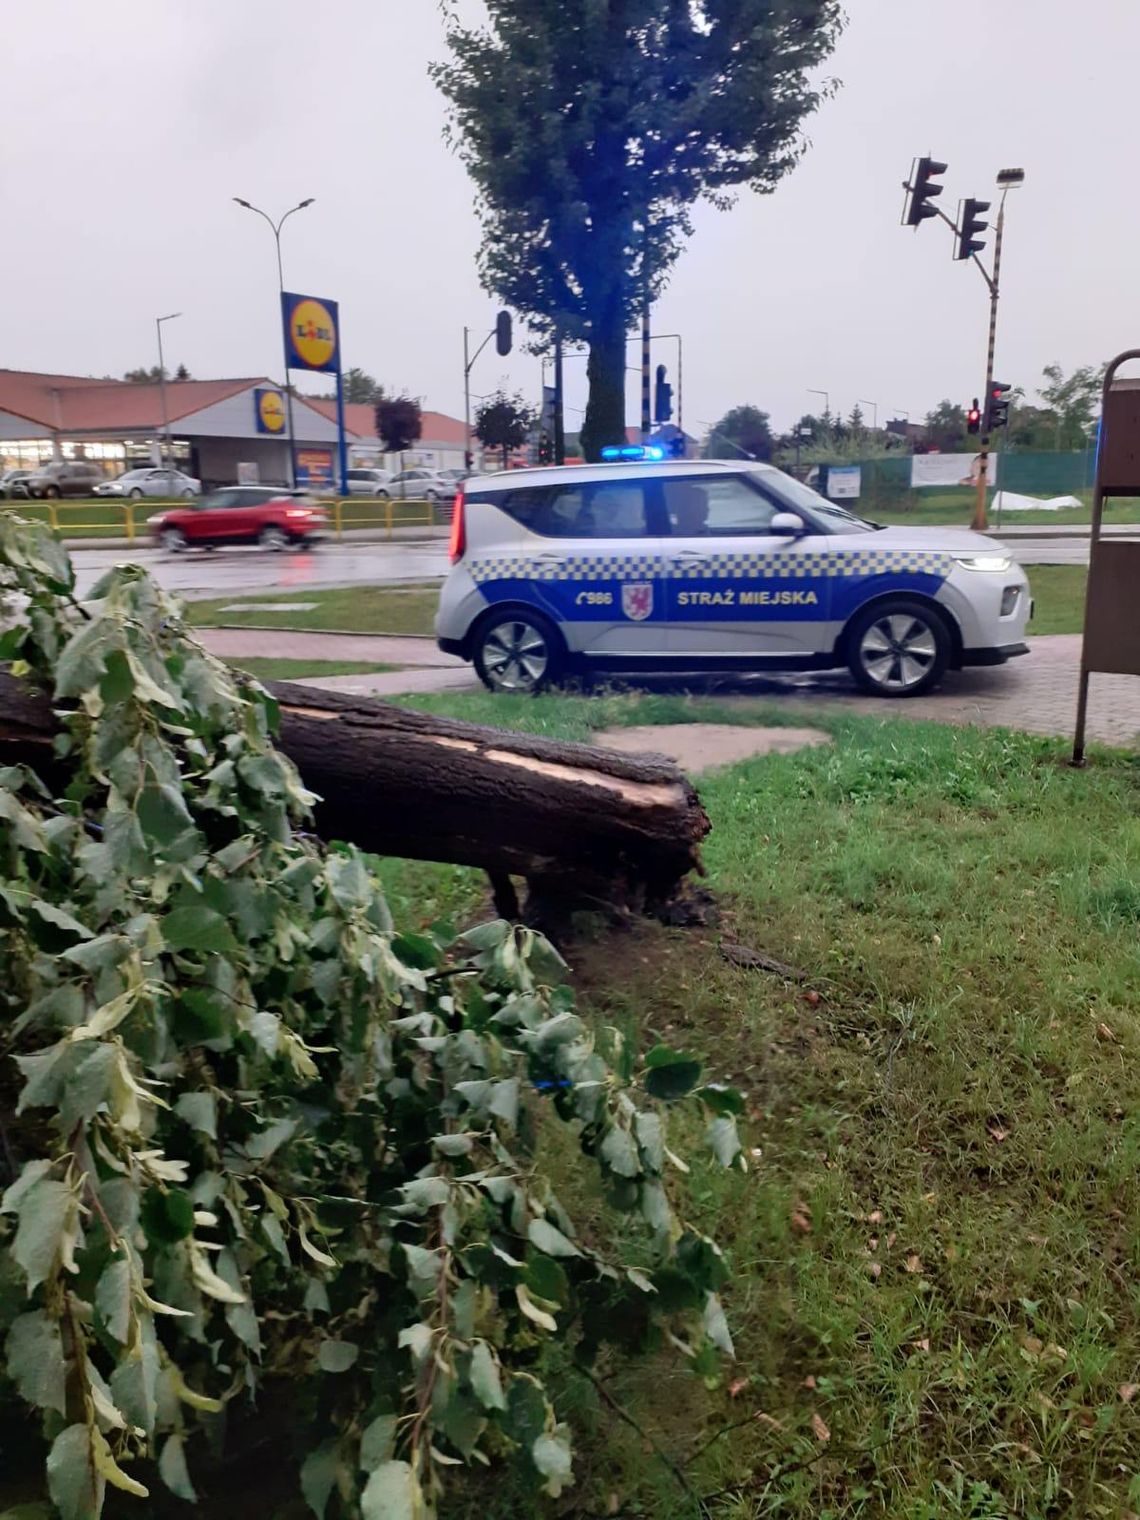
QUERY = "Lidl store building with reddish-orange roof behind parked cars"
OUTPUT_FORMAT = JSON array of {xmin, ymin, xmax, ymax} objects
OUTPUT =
[{"xmin": 0, "ymin": 369, "xmax": 464, "ymax": 488}]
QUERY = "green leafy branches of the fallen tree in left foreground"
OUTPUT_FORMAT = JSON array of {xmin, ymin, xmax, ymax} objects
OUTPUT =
[{"xmin": 0, "ymin": 520, "xmax": 742, "ymax": 1520}]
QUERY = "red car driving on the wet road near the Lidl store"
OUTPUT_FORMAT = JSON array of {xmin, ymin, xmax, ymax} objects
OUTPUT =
[{"xmin": 147, "ymin": 485, "xmax": 328, "ymax": 553}]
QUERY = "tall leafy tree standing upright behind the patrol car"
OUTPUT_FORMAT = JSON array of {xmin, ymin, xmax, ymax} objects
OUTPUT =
[{"xmin": 433, "ymin": 0, "xmax": 842, "ymax": 459}]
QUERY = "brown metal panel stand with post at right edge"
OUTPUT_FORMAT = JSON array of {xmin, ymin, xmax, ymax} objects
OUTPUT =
[{"xmin": 1073, "ymin": 348, "xmax": 1140, "ymax": 765}]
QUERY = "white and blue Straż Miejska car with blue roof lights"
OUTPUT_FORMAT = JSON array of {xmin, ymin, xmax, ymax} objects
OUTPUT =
[{"xmin": 436, "ymin": 450, "xmax": 1031, "ymax": 696}]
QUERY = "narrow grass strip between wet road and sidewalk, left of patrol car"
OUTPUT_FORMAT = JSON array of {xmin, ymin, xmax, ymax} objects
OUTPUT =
[{"xmin": 185, "ymin": 585, "xmax": 439, "ymax": 637}]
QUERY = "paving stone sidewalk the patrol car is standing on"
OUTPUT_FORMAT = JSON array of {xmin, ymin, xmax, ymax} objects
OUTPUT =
[{"xmin": 201, "ymin": 628, "xmax": 1140, "ymax": 748}]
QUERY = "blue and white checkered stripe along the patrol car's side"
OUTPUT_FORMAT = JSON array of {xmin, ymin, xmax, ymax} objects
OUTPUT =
[{"xmin": 468, "ymin": 549, "xmax": 953, "ymax": 585}]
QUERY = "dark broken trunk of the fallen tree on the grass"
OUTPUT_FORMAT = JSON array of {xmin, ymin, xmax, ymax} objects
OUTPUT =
[{"xmin": 0, "ymin": 672, "xmax": 710, "ymax": 910}]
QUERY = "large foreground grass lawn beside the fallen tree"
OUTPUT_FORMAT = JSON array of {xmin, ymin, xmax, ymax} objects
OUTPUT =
[{"xmin": 366, "ymin": 693, "xmax": 1140, "ymax": 1520}]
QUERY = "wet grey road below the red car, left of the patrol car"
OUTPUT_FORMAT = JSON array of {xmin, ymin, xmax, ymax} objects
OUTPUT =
[{"xmin": 71, "ymin": 540, "xmax": 447, "ymax": 600}]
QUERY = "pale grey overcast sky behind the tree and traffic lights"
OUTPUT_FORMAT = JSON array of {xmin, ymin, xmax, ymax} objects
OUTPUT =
[{"xmin": 0, "ymin": 0, "xmax": 1140, "ymax": 432}]
